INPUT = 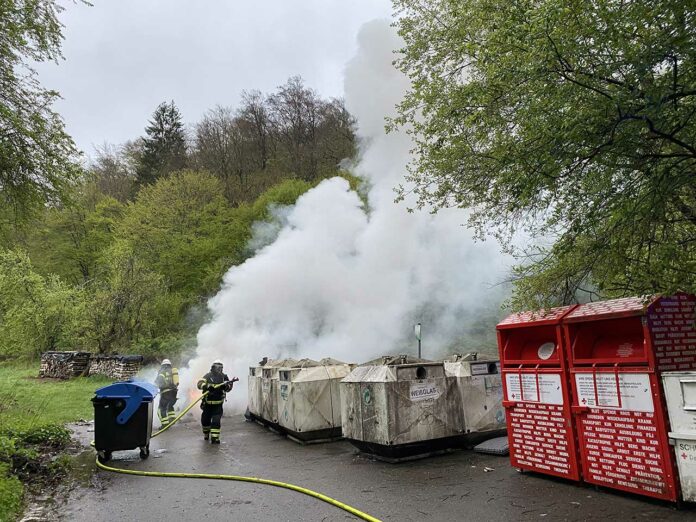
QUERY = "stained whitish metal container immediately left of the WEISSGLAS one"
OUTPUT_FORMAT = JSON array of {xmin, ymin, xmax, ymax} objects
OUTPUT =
[{"xmin": 277, "ymin": 358, "xmax": 352, "ymax": 443}]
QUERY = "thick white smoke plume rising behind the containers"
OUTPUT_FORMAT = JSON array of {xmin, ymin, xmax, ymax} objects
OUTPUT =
[{"xmin": 182, "ymin": 21, "xmax": 509, "ymax": 409}]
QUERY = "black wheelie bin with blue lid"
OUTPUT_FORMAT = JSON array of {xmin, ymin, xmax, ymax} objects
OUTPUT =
[{"xmin": 92, "ymin": 381, "xmax": 158, "ymax": 462}]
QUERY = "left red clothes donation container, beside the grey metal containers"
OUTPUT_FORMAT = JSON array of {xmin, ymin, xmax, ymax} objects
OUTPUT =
[{"xmin": 497, "ymin": 306, "xmax": 580, "ymax": 480}]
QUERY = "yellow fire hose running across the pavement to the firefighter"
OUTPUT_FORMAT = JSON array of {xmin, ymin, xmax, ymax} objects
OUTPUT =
[{"xmin": 92, "ymin": 386, "xmax": 381, "ymax": 522}]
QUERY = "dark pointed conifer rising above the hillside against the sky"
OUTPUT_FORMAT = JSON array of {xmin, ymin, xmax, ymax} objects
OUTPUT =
[{"xmin": 137, "ymin": 101, "xmax": 186, "ymax": 185}]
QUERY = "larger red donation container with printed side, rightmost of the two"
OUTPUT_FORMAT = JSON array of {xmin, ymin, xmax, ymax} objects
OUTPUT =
[{"xmin": 563, "ymin": 294, "xmax": 696, "ymax": 501}]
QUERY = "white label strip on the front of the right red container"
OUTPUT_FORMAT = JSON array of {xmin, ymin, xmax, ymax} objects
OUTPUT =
[{"xmin": 575, "ymin": 373, "xmax": 655, "ymax": 412}]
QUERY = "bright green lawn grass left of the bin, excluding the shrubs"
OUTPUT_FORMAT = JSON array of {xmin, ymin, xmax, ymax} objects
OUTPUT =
[{"xmin": 0, "ymin": 362, "xmax": 112, "ymax": 522}]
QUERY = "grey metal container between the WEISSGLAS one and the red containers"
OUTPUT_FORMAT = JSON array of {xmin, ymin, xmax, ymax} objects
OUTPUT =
[{"xmin": 443, "ymin": 353, "xmax": 506, "ymax": 447}]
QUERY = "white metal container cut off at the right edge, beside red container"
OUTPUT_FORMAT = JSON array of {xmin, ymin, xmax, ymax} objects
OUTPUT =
[{"xmin": 662, "ymin": 370, "xmax": 696, "ymax": 502}]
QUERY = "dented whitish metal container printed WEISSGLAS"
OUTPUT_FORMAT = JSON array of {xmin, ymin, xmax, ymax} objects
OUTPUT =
[{"xmin": 340, "ymin": 355, "xmax": 463, "ymax": 462}]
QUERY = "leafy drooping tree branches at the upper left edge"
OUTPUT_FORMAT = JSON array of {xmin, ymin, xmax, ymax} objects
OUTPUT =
[{"xmin": 0, "ymin": 0, "xmax": 79, "ymax": 221}]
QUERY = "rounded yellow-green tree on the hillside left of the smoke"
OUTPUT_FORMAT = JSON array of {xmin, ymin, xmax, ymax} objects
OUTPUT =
[{"xmin": 117, "ymin": 171, "xmax": 249, "ymax": 301}]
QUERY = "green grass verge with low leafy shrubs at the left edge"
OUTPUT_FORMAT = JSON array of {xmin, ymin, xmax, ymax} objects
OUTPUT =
[{"xmin": 0, "ymin": 362, "xmax": 112, "ymax": 522}]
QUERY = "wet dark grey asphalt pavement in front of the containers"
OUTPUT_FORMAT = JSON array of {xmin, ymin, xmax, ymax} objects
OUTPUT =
[{"xmin": 57, "ymin": 416, "xmax": 696, "ymax": 522}]
